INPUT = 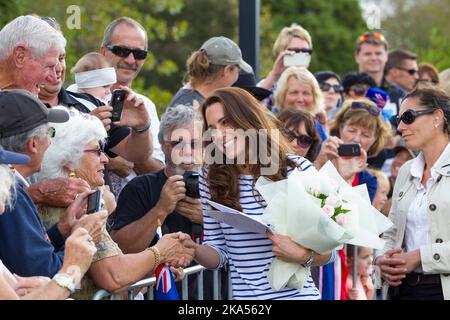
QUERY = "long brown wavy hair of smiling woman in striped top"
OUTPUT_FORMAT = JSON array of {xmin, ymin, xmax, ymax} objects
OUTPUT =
[{"xmin": 201, "ymin": 87, "xmax": 296, "ymax": 211}]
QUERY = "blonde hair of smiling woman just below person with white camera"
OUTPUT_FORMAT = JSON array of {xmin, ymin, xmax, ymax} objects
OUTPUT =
[{"xmin": 274, "ymin": 67, "xmax": 325, "ymax": 115}]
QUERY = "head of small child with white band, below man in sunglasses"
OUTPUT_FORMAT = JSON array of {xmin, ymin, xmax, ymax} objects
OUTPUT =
[{"xmin": 67, "ymin": 52, "xmax": 117, "ymax": 103}]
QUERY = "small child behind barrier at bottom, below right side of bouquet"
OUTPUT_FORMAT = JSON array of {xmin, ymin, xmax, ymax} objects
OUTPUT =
[{"xmin": 346, "ymin": 244, "xmax": 375, "ymax": 300}]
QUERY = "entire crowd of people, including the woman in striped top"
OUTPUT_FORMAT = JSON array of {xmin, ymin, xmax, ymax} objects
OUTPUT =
[{"xmin": 0, "ymin": 15, "xmax": 450, "ymax": 300}]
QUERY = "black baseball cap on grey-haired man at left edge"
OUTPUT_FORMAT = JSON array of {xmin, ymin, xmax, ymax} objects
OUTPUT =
[{"xmin": 0, "ymin": 89, "xmax": 69, "ymax": 138}]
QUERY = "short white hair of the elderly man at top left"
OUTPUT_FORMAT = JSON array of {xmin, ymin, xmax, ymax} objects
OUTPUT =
[{"xmin": 0, "ymin": 16, "xmax": 66, "ymax": 61}]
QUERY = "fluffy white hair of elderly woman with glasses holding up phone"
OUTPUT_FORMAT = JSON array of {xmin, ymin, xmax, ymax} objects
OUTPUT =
[{"xmin": 36, "ymin": 106, "xmax": 107, "ymax": 181}]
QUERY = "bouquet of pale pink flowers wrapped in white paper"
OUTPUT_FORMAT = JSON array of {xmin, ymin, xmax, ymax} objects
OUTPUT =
[{"xmin": 256, "ymin": 162, "xmax": 392, "ymax": 290}]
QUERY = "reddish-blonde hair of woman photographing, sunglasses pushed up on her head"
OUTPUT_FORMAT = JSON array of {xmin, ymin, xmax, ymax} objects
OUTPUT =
[{"xmin": 330, "ymin": 98, "xmax": 391, "ymax": 156}]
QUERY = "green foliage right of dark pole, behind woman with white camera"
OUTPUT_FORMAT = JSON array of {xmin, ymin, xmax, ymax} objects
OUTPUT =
[{"xmin": 261, "ymin": 0, "xmax": 367, "ymax": 76}]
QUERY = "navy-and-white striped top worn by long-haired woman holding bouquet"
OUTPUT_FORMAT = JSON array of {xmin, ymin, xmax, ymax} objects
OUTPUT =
[{"xmin": 200, "ymin": 155, "xmax": 335, "ymax": 300}]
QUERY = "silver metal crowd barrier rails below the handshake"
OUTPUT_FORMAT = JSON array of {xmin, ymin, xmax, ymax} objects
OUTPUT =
[{"xmin": 92, "ymin": 265, "xmax": 232, "ymax": 300}]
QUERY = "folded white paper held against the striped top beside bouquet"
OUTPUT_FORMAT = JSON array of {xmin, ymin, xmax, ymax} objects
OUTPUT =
[{"xmin": 205, "ymin": 200, "xmax": 273, "ymax": 234}]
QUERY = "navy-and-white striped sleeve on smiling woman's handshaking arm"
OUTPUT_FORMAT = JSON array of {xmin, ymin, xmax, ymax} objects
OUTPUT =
[{"xmin": 199, "ymin": 167, "xmax": 228, "ymax": 269}]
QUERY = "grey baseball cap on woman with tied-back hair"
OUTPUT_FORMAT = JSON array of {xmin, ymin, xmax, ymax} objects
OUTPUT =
[{"xmin": 200, "ymin": 37, "xmax": 253, "ymax": 73}]
